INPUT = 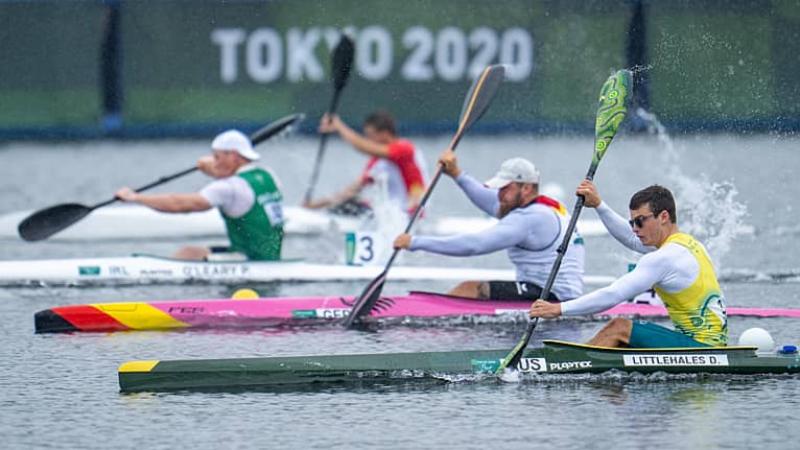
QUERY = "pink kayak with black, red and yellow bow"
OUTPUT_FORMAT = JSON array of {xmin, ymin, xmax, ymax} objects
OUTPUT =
[{"xmin": 35, "ymin": 292, "xmax": 800, "ymax": 333}]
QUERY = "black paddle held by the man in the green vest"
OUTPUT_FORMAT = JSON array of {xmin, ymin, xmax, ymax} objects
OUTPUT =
[{"xmin": 17, "ymin": 114, "xmax": 304, "ymax": 242}]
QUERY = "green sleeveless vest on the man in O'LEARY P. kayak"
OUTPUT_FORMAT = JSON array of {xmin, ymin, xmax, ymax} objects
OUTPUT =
[{"xmin": 220, "ymin": 167, "xmax": 283, "ymax": 261}]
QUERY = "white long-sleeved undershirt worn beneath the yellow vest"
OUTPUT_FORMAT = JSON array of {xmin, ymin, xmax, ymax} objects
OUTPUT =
[{"xmin": 561, "ymin": 202, "xmax": 700, "ymax": 316}]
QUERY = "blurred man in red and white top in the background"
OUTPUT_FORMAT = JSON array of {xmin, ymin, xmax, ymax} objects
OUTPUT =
[{"xmin": 303, "ymin": 111, "xmax": 426, "ymax": 218}]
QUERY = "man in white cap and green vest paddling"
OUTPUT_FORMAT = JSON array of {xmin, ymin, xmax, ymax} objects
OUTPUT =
[{"xmin": 116, "ymin": 130, "xmax": 283, "ymax": 261}]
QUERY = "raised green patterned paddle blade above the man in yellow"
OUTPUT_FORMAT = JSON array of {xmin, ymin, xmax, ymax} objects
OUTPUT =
[{"xmin": 592, "ymin": 69, "xmax": 633, "ymax": 165}]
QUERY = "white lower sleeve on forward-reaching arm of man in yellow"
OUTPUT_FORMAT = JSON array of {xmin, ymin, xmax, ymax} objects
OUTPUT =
[{"xmin": 561, "ymin": 252, "xmax": 672, "ymax": 316}]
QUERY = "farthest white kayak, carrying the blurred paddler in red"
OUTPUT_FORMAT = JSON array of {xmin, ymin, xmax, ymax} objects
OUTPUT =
[{"xmin": 0, "ymin": 205, "xmax": 606, "ymax": 240}]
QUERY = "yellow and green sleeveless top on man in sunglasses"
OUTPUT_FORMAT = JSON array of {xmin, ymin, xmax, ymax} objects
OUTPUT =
[{"xmin": 654, "ymin": 233, "xmax": 728, "ymax": 346}]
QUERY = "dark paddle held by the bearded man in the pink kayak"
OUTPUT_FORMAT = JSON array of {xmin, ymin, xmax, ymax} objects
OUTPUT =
[{"xmin": 344, "ymin": 65, "xmax": 505, "ymax": 328}]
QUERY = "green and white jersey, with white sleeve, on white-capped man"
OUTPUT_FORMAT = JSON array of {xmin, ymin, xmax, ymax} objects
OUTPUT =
[{"xmin": 200, "ymin": 165, "xmax": 283, "ymax": 260}]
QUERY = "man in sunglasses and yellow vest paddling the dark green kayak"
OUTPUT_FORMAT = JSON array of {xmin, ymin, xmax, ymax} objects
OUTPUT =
[{"xmin": 530, "ymin": 181, "xmax": 728, "ymax": 348}]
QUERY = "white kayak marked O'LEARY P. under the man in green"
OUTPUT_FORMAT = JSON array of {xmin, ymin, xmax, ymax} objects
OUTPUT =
[{"xmin": 0, "ymin": 255, "xmax": 614, "ymax": 285}]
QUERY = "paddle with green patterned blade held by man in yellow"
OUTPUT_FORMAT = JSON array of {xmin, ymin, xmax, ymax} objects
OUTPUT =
[{"xmin": 495, "ymin": 70, "xmax": 632, "ymax": 375}]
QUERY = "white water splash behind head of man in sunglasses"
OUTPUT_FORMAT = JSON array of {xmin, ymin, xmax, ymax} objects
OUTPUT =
[{"xmin": 634, "ymin": 108, "xmax": 753, "ymax": 265}]
